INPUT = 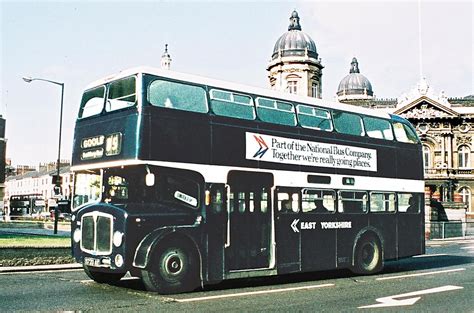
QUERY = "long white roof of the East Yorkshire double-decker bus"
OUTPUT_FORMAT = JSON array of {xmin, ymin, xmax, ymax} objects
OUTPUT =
[{"xmin": 86, "ymin": 66, "xmax": 391, "ymax": 119}]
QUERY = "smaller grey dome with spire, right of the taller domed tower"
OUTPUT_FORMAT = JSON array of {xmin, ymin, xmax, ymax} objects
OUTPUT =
[{"xmin": 337, "ymin": 58, "xmax": 374, "ymax": 101}]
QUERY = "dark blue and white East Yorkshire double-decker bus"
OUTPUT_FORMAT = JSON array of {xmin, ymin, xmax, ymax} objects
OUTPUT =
[{"xmin": 71, "ymin": 68, "xmax": 425, "ymax": 293}]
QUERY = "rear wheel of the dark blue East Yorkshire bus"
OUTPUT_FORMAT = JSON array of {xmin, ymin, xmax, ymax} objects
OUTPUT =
[{"xmin": 352, "ymin": 236, "xmax": 383, "ymax": 275}]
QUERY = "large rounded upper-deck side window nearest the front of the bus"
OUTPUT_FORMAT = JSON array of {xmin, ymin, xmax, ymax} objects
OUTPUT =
[{"xmin": 148, "ymin": 79, "xmax": 208, "ymax": 113}]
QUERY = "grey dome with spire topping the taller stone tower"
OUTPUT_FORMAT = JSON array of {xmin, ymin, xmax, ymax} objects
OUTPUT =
[{"xmin": 272, "ymin": 11, "xmax": 318, "ymax": 60}]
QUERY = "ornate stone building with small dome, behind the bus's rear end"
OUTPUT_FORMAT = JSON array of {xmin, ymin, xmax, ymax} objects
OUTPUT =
[{"xmin": 337, "ymin": 70, "xmax": 474, "ymax": 218}]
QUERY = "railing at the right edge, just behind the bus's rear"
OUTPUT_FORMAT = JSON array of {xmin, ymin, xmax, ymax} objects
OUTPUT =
[{"xmin": 426, "ymin": 220, "xmax": 474, "ymax": 239}]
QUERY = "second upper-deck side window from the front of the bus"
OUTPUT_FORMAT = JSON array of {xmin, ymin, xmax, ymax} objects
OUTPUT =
[{"xmin": 210, "ymin": 89, "xmax": 255, "ymax": 120}]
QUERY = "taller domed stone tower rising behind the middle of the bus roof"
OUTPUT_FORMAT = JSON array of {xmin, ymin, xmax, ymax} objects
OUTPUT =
[{"xmin": 267, "ymin": 11, "xmax": 324, "ymax": 98}]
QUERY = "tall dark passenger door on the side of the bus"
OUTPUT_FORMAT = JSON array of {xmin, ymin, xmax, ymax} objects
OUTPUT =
[{"xmin": 225, "ymin": 171, "xmax": 273, "ymax": 271}]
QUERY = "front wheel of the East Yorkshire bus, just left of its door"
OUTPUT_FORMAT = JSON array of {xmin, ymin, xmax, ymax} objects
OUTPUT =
[{"xmin": 142, "ymin": 245, "xmax": 199, "ymax": 294}]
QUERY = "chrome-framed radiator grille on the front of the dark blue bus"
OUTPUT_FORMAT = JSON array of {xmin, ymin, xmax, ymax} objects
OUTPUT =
[{"xmin": 81, "ymin": 212, "xmax": 113, "ymax": 255}]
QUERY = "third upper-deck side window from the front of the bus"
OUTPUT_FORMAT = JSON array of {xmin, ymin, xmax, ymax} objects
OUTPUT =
[{"xmin": 257, "ymin": 98, "xmax": 296, "ymax": 126}]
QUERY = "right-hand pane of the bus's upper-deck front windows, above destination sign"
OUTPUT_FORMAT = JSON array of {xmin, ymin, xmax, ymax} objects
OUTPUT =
[{"xmin": 105, "ymin": 76, "xmax": 136, "ymax": 112}]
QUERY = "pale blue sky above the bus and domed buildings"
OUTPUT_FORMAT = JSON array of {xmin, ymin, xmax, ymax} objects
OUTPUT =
[{"xmin": 0, "ymin": 0, "xmax": 474, "ymax": 166}]
